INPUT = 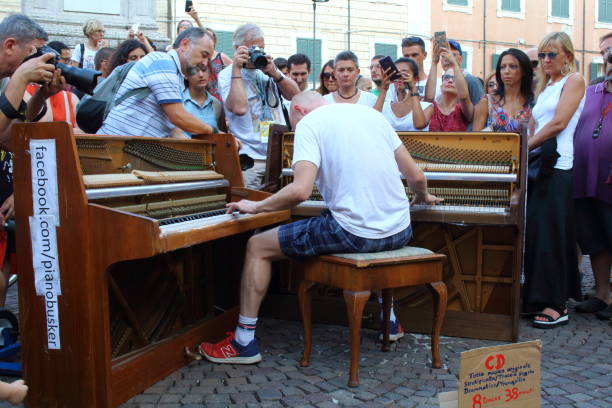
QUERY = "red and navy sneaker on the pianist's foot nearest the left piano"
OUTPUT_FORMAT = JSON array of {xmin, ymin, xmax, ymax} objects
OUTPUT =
[{"xmin": 198, "ymin": 332, "xmax": 261, "ymax": 364}]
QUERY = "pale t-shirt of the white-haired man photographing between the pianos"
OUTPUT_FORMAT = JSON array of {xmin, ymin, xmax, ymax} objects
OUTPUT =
[{"xmin": 217, "ymin": 65, "xmax": 285, "ymax": 160}]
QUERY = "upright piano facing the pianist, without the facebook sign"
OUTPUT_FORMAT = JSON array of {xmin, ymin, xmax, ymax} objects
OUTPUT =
[{"xmin": 266, "ymin": 128, "xmax": 526, "ymax": 341}]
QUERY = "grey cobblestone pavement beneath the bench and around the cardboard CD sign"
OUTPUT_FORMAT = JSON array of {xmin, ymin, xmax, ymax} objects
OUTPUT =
[{"xmin": 0, "ymin": 264, "xmax": 612, "ymax": 408}]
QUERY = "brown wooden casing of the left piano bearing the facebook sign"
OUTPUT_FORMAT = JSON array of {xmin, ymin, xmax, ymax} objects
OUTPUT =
[{"xmin": 13, "ymin": 122, "xmax": 289, "ymax": 408}]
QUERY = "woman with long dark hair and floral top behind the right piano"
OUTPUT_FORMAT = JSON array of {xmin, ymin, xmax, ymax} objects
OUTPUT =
[{"xmin": 473, "ymin": 48, "xmax": 534, "ymax": 134}]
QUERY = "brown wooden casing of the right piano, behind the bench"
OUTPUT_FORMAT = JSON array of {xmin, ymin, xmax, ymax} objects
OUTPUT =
[{"xmin": 263, "ymin": 126, "xmax": 527, "ymax": 341}]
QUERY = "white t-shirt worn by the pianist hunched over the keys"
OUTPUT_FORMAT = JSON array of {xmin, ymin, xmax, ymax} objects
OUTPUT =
[{"xmin": 293, "ymin": 103, "xmax": 410, "ymax": 239}]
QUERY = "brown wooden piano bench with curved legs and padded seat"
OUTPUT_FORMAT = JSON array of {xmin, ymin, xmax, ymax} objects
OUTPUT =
[{"xmin": 298, "ymin": 247, "xmax": 447, "ymax": 387}]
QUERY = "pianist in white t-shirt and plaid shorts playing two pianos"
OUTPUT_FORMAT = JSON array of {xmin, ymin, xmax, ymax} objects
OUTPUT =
[{"xmin": 199, "ymin": 91, "xmax": 440, "ymax": 364}]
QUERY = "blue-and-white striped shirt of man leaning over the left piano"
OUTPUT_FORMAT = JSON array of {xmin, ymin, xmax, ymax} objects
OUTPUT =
[{"xmin": 98, "ymin": 50, "xmax": 185, "ymax": 137}]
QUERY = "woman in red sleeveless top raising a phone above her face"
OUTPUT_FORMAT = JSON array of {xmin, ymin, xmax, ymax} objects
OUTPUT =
[{"xmin": 429, "ymin": 47, "xmax": 474, "ymax": 132}]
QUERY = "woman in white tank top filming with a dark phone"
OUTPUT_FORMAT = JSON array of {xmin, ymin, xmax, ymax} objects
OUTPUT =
[{"xmin": 374, "ymin": 57, "xmax": 433, "ymax": 132}]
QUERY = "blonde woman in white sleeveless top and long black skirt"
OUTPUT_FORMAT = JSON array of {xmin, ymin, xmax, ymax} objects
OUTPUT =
[{"xmin": 523, "ymin": 32, "xmax": 585, "ymax": 329}]
